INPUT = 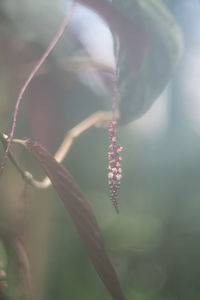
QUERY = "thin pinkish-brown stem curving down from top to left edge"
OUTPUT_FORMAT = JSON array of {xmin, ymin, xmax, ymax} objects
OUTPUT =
[{"xmin": 0, "ymin": 0, "xmax": 76, "ymax": 177}]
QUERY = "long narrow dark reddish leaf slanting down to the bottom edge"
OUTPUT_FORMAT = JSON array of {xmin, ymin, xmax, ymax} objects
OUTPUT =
[{"xmin": 26, "ymin": 140, "xmax": 124, "ymax": 300}]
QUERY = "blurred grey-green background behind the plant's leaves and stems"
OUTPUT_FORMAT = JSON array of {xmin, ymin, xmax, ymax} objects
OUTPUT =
[{"xmin": 0, "ymin": 0, "xmax": 200, "ymax": 300}]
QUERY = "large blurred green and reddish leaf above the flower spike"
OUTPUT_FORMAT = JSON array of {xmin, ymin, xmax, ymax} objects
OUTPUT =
[{"xmin": 79, "ymin": 0, "xmax": 182, "ymax": 123}]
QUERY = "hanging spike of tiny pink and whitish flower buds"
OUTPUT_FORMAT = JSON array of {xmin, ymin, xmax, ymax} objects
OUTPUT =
[{"xmin": 108, "ymin": 121, "xmax": 123, "ymax": 213}]
